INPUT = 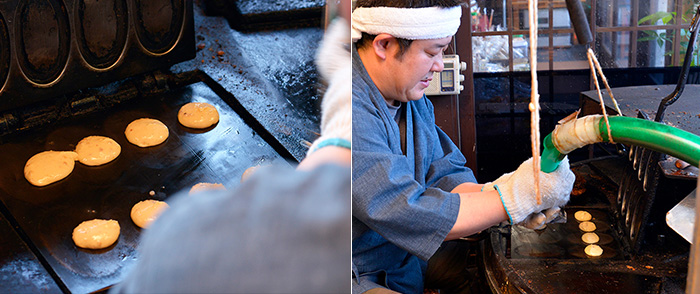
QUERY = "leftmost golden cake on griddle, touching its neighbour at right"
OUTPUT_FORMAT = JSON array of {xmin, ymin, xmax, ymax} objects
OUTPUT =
[{"xmin": 24, "ymin": 151, "xmax": 78, "ymax": 187}]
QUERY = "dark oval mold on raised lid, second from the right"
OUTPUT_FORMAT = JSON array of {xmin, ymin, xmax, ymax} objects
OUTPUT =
[{"xmin": 75, "ymin": 0, "xmax": 129, "ymax": 71}]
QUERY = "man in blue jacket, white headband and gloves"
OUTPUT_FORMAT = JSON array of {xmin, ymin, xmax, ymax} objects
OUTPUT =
[{"xmin": 352, "ymin": 0, "xmax": 575, "ymax": 293}]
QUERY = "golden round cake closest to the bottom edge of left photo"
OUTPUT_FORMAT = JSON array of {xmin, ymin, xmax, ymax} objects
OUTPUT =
[{"xmin": 73, "ymin": 219, "xmax": 119, "ymax": 249}]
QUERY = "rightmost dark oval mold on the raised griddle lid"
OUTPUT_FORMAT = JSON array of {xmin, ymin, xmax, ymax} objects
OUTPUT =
[{"xmin": 131, "ymin": 0, "xmax": 185, "ymax": 56}]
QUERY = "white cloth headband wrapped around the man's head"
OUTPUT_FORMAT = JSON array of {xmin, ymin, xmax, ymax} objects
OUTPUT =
[{"xmin": 352, "ymin": 6, "xmax": 462, "ymax": 42}]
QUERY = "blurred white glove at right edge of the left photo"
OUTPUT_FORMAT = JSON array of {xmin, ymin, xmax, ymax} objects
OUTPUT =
[{"xmin": 307, "ymin": 18, "xmax": 352, "ymax": 155}]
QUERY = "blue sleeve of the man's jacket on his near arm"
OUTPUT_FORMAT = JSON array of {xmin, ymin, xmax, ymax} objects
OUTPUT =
[{"xmin": 352, "ymin": 89, "xmax": 459, "ymax": 260}]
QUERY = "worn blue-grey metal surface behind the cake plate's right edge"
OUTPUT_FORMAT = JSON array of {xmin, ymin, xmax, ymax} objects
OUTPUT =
[{"xmin": 178, "ymin": 2, "xmax": 323, "ymax": 161}]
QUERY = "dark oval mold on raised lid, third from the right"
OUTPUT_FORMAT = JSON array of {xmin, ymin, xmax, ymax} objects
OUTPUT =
[{"xmin": 15, "ymin": 0, "xmax": 70, "ymax": 87}]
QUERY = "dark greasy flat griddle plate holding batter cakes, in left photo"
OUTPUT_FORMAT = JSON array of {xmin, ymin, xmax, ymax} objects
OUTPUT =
[{"xmin": 0, "ymin": 83, "xmax": 287, "ymax": 293}]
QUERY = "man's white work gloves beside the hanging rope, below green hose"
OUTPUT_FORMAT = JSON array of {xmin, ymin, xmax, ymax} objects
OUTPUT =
[{"xmin": 483, "ymin": 157, "xmax": 576, "ymax": 227}]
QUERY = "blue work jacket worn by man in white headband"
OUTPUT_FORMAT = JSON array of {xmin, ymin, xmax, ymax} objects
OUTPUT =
[{"xmin": 352, "ymin": 48, "xmax": 476, "ymax": 293}]
